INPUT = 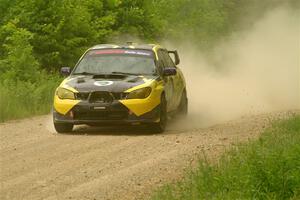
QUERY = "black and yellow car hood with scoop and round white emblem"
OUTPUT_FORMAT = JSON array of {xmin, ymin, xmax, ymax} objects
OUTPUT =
[{"xmin": 62, "ymin": 74, "xmax": 159, "ymax": 92}]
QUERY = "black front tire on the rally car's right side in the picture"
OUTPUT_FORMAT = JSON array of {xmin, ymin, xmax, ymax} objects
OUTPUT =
[{"xmin": 151, "ymin": 95, "xmax": 168, "ymax": 133}]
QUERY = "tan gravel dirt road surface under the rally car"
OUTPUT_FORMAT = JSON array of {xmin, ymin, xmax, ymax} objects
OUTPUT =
[{"xmin": 0, "ymin": 112, "xmax": 294, "ymax": 200}]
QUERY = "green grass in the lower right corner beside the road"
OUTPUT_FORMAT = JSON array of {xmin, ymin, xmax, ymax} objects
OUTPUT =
[{"xmin": 151, "ymin": 116, "xmax": 300, "ymax": 200}]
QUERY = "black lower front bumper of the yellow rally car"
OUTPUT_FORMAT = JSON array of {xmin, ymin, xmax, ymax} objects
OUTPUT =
[{"xmin": 53, "ymin": 101, "xmax": 159, "ymax": 125}]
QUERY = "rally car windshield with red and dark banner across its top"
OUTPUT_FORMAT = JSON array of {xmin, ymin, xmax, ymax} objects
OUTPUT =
[{"xmin": 73, "ymin": 49, "xmax": 156, "ymax": 75}]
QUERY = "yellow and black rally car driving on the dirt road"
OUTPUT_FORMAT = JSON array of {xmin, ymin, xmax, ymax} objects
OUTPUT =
[{"xmin": 53, "ymin": 44, "xmax": 188, "ymax": 133}]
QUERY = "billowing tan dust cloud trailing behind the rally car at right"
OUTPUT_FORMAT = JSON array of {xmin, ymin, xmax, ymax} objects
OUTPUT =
[{"xmin": 170, "ymin": 8, "xmax": 300, "ymax": 127}]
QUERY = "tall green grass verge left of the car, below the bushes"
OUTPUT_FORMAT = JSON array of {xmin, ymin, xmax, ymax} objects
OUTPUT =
[{"xmin": 0, "ymin": 77, "xmax": 60, "ymax": 122}]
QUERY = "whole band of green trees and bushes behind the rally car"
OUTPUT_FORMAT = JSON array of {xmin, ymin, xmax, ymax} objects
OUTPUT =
[{"xmin": 0, "ymin": 0, "xmax": 300, "ymax": 120}]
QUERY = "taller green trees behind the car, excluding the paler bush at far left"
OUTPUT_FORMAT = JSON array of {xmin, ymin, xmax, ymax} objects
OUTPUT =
[{"xmin": 0, "ymin": 0, "xmax": 299, "ymax": 70}]
